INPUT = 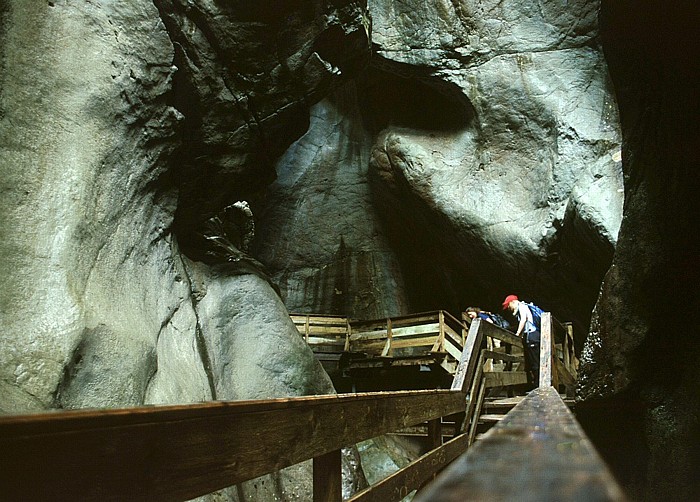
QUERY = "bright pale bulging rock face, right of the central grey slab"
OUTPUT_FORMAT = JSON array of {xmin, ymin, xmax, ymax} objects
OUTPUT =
[{"xmin": 371, "ymin": 1, "xmax": 623, "ymax": 334}]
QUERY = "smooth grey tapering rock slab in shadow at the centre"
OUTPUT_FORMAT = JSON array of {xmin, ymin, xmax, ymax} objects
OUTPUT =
[{"xmin": 254, "ymin": 86, "xmax": 407, "ymax": 319}]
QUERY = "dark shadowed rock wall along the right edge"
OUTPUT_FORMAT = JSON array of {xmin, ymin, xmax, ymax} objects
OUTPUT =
[{"xmin": 577, "ymin": 0, "xmax": 700, "ymax": 501}]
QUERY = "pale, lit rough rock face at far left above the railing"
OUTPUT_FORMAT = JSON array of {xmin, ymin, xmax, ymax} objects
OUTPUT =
[{"xmin": 0, "ymin": 1, "xmax": 183, "ymax": 412}]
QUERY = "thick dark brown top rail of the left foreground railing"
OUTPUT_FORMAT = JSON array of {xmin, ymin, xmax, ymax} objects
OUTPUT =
[{"xmin": 0, "ymin": 390, "xmax": 465, "ymax": 501}]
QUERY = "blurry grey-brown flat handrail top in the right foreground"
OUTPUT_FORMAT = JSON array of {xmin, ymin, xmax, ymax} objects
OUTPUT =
[{"xmin": 414, "ymin": 387, "xmax": 625, "ymax": 502}]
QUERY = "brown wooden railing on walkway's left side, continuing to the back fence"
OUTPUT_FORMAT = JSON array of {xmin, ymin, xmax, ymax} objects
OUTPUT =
[{"xmin": 0, "ymin": 314, "xmax": 612, "ymax": 502}]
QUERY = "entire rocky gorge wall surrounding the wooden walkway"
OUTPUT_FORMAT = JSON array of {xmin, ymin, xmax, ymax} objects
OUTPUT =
[{"xmin": 0, "ymin": 0, "xmax": 700, "ymax": 500}]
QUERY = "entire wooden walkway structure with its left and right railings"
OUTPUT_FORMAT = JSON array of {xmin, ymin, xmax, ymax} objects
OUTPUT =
[{"xmin": 0, "ymin": 312, "xmax": 620, "ymax": 502}]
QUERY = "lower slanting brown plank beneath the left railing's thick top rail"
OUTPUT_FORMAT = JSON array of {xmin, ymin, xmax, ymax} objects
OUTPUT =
[{"xmin": 348, "ymin": 434, "xmax": 468, "ymax": 502}]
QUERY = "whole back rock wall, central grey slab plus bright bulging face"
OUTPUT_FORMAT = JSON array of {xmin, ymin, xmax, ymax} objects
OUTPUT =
[{"xmin": 257, "ymin": 0, "xmax": 623, "ymax": 343}]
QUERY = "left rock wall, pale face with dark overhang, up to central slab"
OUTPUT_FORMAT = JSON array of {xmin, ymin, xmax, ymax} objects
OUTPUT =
[{"xmin": 0, "ymin": 0, "xmax": 369, "ymax": 500}]
